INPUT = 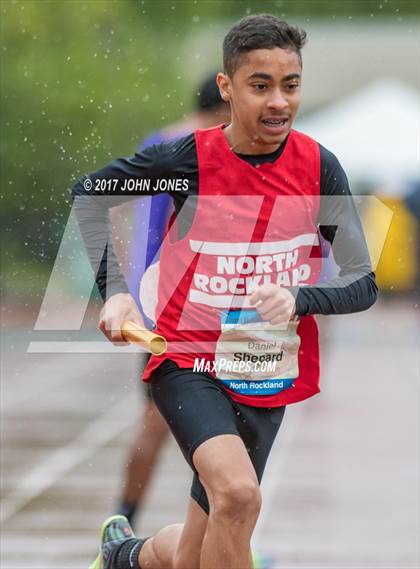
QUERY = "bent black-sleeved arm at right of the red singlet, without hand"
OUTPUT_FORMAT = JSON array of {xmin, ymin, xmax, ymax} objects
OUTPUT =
[{"xmin": 296, "ymin": 145, "xmax": 378, "ymax": 316}]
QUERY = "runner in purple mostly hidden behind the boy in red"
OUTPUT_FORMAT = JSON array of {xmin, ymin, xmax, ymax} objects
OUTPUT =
[{"xmin": 113, "ymin": 73, "xmax": 230, "ymax": 524}]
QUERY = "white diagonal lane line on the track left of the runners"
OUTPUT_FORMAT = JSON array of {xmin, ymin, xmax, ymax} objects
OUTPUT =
[{"xmin": 0, "ymin": 394, "xmax": 137, "ymax": 523}]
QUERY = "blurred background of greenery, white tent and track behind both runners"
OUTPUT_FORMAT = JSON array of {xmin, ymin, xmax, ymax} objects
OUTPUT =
[{"xmin": 0, "ymin": 0, "xmax": 420, "ymax": 569}]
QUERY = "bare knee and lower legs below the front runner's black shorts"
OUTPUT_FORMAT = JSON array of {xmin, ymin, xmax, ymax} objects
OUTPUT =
[{"xmin": 139, "ymin": 435, "xmax": 261, "ymax": 569}]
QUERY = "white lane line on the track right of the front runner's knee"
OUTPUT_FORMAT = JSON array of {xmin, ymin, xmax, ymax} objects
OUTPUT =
[{"xmin": 252, "ymin": 403, "xmax": 305, "ymax": 550}]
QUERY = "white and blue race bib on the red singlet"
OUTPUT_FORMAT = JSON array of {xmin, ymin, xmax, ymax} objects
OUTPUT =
[{"xmin": 215, "ymin": 310, "xmax": 300, "ymax": 395}]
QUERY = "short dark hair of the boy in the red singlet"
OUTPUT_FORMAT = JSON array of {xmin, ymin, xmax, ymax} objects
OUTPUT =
[{"xmin": 223, "ymin": 14, "xmax": 306, "ymax": 77}]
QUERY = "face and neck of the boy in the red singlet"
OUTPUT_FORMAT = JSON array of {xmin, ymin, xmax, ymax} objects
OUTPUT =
[{"xmin": 218, "ymin": 47, "xmax": 302, "ymax": 154}]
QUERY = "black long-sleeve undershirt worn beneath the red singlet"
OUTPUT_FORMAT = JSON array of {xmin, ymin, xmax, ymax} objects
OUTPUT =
[{"xmin": 73, "ymin": 134, "xmax": 377, "ymax": 315}]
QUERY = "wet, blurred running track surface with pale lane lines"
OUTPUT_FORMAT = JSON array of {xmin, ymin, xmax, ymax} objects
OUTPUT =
[{"xmin": 1, "ymin": 300, "xmax": 420, "ymax": 569}]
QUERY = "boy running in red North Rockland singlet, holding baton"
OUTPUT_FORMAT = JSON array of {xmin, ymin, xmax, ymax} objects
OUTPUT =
[{"xmin": 74, "ymin": 15, "xmax": 377, "ymax": 569}]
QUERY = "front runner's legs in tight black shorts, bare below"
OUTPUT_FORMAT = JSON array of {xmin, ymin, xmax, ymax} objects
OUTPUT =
[{"xmin": 94, "ymin": 364, "xmax": 284, "ymax": 569}]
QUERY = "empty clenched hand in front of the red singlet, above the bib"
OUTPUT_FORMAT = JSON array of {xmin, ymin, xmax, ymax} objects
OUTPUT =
[{"xmin": 250, "ymin": 284, "xmax": 295, "ymax": 324}]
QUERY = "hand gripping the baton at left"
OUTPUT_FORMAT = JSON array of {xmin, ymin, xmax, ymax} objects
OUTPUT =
[{"xmin": 98, "ymin": 293, "xmax": 146, "ymax": 346}]
